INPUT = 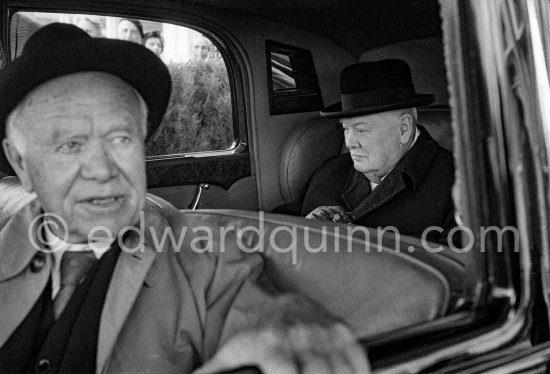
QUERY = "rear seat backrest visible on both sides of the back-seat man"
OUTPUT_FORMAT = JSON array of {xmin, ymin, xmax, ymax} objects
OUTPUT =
[{"xmin": 279, "ymin": 107, "xmax": 453, "ymax": 203}]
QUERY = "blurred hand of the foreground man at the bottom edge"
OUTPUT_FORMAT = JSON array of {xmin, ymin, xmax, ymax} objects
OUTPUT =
[{"xmin": 195, "ymin": 323, "xmax": 370, "ymax": 374}]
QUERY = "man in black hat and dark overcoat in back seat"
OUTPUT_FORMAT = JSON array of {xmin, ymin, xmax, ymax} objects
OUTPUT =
[{"xmin": 302, "ymin": 59, "xmax": 454, "ymax": 239}]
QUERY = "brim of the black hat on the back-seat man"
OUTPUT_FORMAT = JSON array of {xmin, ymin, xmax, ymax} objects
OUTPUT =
[{"xmin": 320, "ymin": 94, "xmax": 435, "ymax": 118}]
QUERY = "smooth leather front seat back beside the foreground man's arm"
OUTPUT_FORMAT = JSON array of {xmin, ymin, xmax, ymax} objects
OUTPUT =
[{"xmin": 185, "ymin": 210, "xmax": 467, "ymax": 338}]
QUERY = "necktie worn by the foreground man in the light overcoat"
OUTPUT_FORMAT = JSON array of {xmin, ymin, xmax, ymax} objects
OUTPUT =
[{"xmin": 53, "ymin": 251, "xmax": 97, "ymax": 319}]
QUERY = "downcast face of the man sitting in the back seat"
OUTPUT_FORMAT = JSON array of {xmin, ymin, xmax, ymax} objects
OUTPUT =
[{"xmin": 340, "ymin": 111, "xmax": 410, "ymax": 183}]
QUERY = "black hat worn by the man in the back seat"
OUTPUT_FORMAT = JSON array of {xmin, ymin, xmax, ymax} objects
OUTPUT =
[{"xmin": 321, "ymin": 59, "xmax": 435, "ymax": 118}]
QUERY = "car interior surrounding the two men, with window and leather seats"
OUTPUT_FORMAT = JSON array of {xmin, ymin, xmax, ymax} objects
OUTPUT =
[{"xmin": 0, "ymin": 0, "xmax": 548, "ymax": 373}]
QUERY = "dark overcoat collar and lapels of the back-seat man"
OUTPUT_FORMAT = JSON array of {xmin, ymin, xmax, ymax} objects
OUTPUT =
[{"xmin": 341, "ymin": 126, "xmax": 439, "ymax": 220}]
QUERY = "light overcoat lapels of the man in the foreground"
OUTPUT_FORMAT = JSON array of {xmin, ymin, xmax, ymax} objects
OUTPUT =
[{"xmin": 0, "ymin": 200, "xmax": 158, "ymax": 373}]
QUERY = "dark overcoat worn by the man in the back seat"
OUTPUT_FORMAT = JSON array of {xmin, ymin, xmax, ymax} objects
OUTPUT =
[{"xmin": 302, "ymin": 127, "xmax": 455, "ymax": 240}]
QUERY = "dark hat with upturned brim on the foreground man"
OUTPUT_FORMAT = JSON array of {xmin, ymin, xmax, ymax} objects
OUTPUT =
[{"xmin": 0, "ymin": 23, "xmax": 172, "ymax": 175}]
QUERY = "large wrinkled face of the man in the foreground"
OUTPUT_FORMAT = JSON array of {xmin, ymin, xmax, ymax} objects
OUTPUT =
[{"xmin": 4, "ymin": 72, "xmax": 146, "ymax": 242}]
